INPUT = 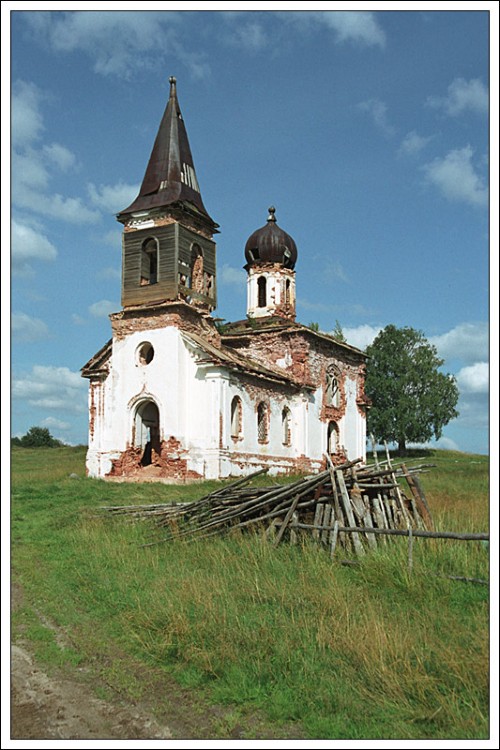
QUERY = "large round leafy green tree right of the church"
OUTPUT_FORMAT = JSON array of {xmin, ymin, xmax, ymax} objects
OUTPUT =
[{"xmin": 365, "ymin": 325, "xmax": 459, "ymax": 453}]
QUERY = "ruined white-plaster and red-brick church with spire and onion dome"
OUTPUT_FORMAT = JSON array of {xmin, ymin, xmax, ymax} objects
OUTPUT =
[{"xmin": 82, "ymin": 77, "xmax": 369, "ymax": 482}]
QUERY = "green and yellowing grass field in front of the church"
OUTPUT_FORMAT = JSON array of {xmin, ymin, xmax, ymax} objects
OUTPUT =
[{"xmin": 11, "ymin": 448, "xmax": 489, "ymax": 739}]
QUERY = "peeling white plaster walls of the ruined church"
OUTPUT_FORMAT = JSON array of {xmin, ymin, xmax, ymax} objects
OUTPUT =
[{"xmin": 87, "ymin": 325, "xmax": 366, "ymax": 479}]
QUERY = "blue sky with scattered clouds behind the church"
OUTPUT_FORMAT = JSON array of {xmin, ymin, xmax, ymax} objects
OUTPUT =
[{"xmin": 2, "ymin": 2, "xmax": 498, "ymax": 453}]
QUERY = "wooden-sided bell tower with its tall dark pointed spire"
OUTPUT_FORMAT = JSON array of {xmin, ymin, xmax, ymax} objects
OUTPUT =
[{"xmin": 117, "ymin": 76, "xmax": 218, "ymax": 312}]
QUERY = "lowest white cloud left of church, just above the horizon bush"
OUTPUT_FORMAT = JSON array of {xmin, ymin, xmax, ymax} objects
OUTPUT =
[{"xmin": 12, "ymin": 365, "xmax": 87, "ymax": 413}]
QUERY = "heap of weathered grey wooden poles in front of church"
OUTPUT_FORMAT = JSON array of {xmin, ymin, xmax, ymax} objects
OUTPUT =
[{"xmin": 97, "ymin": 456, "xmax": 432, "ymax": 556}]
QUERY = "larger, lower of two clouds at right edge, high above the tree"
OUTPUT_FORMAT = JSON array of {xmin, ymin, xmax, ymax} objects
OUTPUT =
[{"xmin": 422, "ymin": 146, "xmax": 488, "ymax": 206}]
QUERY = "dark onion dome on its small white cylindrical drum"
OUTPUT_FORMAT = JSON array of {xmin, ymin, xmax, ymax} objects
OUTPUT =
[{"xmin": 244, "ymin": 206, "xmax": 297, "ymax": 320}]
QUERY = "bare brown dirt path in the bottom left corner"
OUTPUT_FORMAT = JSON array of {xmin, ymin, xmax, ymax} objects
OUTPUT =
[{"xmin": 8, "ymin": 583, "xmax": 225, "ymax": 740}]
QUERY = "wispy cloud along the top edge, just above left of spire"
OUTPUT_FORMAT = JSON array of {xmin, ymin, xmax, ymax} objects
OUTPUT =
[{"xmin": 23, "ymin": 10, "xmax": 209, "ymax": 79}]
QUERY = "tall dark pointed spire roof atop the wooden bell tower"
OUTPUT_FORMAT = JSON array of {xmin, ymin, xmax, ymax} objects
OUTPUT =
[{"xmin": 118, "ymin": 76, "xmax": 217, "ymax": 227}]
